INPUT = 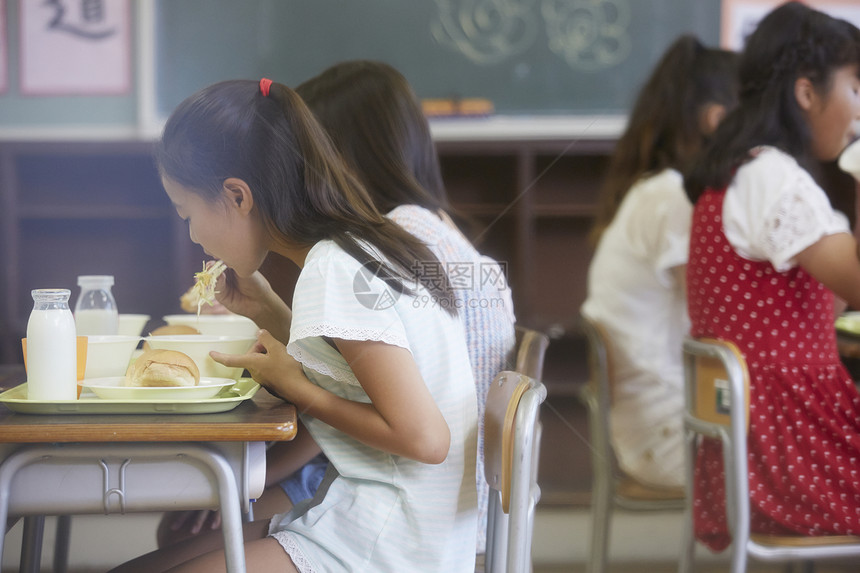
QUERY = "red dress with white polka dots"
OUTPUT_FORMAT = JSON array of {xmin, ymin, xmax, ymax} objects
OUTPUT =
[{"xmin": 687, "ymin": 185, "xmax": 860, "ymax": 551}]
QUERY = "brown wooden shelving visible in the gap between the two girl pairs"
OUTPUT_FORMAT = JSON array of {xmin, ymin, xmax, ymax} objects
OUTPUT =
[{"xmin": 437, "ymin": 138, "xmax": 614, "ymax": 394}]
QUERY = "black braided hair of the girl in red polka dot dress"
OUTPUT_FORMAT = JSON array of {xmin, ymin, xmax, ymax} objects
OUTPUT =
[{"xmin": 684, "ymin": 2, "xmax": 860, "ymax": 202}]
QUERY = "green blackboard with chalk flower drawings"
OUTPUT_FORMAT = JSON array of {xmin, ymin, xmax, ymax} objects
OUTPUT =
[{"xmin": 155, "ymin": 0, "xmax": 720, "ymax": 116}]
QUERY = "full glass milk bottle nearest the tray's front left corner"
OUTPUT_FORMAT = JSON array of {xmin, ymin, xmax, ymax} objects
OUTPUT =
[{"xmin": 27, "ymin": 289, "xmax": 78, "ymax": 400}]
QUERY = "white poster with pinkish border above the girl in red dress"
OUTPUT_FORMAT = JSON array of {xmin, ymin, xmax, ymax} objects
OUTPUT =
[{"xmin": 720, "ymin": 0, "xmax": 860, "ymax": 51}]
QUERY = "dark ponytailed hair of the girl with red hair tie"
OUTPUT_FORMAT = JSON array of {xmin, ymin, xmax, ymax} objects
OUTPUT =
[{"xmin": 155, "ymin": 80, "xmax": 456, "ymax": 314}]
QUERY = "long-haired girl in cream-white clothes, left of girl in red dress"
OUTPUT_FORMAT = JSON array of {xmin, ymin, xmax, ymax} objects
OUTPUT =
[{"xmin": 582, "ymin": 36, "xmax": 737, "ymax": 487}]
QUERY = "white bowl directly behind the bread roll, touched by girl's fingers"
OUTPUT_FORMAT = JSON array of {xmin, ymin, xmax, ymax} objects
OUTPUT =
[{"xmin": 145, "ymin": 334, "xmax": 257, "ymax": 380}]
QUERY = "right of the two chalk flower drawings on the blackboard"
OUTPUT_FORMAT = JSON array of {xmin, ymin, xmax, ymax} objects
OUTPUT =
[{"xmin": 541, "ymin": 0, "xmax": 631, "ymax": 71}]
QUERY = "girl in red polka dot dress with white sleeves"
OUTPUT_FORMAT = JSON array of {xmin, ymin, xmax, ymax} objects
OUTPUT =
[{"xmin": 685, "ymin": 3, "xmax": 860, "ymax": 550}]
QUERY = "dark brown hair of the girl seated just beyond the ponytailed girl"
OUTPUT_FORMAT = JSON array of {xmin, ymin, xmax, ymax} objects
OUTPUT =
[{"xmin": 296, "ymin": 60, "xmax": 450, "ymax": 213}]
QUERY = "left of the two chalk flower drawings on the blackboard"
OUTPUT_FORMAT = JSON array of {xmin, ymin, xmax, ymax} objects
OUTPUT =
[{"xmin": 430, "ymin": 0, "xmax": 539, "ymax": 65}]
